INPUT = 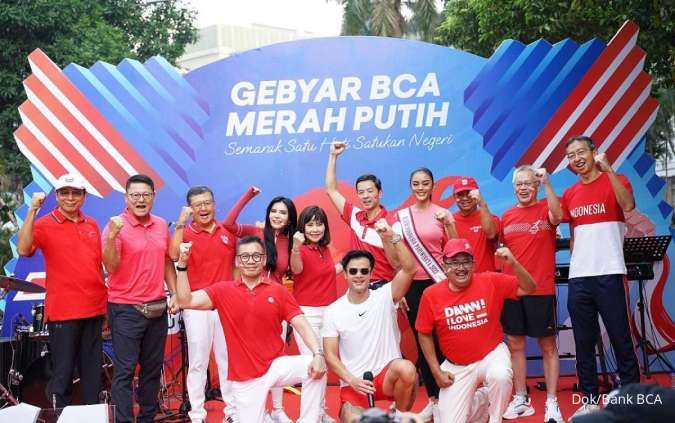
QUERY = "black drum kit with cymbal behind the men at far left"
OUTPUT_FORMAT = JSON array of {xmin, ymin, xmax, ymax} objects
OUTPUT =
[{"xmin": 0, "ymin": 275, "xmax": 113, "ymax": 408}]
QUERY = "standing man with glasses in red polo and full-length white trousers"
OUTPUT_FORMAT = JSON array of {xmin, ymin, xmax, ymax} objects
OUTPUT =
[{"xmin": 169, "ymin": 186, "xmax": 236, "ymax": 421}]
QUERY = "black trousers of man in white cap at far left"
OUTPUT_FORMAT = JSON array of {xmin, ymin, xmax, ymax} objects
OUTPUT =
[{"xmin": 47, "ymin": 316, "xmax": 103, "ymax": 408}]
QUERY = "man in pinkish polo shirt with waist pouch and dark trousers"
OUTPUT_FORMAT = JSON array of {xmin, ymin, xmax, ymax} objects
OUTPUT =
[{"xmin": 102, "ymin": 175, "xmax": 176, "ymax": 423}]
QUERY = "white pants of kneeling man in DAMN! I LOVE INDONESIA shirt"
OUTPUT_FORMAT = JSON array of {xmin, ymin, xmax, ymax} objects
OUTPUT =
[{"xmin": 438, "ymin": 342, "xmax": 513, "ymax": 423}]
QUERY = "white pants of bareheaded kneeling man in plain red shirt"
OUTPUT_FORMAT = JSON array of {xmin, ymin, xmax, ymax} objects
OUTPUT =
[{"xmin": 232, "ymin": 355, "xmax": 326, "ymax": 423}]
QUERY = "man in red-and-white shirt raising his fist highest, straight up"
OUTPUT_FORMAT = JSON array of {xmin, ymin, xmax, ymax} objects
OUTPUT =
[{"xmin": 326, "ymin": 142, "xmax": 399, "ymax": 288}]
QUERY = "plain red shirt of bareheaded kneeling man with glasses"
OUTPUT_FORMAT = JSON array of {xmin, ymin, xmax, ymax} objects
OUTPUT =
[{"xmin": 204, "ymin": 278, "xmax": 302, "ymax": 382}]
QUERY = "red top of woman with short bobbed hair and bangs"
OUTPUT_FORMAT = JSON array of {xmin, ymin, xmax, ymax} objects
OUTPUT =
[{"xmin": 293, "ymin": 245, "xmax": 337, "ymax": 307}]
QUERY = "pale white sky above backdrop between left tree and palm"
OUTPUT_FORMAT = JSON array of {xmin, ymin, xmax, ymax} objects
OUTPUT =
[{"xmin": 185, "ymin": 0, "xmax": 342, "ymax": 36}]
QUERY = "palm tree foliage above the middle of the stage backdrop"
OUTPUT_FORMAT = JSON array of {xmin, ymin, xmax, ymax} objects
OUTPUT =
[{"xmin": 335, "ymin": 0, "xmax": 439, "ymax": 41}]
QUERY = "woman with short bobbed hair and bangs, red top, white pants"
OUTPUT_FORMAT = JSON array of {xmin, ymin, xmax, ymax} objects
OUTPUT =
[{"xmin": 290, "ymin": 206, "xmax": 342, "ymax": 423}]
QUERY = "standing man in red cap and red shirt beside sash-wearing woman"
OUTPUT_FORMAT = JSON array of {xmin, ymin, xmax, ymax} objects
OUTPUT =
[{"xmin": 453, "ymin": 176, "xmax": 499, "ymax": 273}]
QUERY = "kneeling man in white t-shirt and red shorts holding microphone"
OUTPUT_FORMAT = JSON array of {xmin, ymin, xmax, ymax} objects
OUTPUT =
[{"xmin": 321, "ymin": 219, "xmax": 417, "ymax": 423}]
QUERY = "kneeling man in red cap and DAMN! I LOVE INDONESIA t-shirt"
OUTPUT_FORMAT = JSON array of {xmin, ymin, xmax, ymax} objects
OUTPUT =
[{"xmin": 415, "ymin": 238, "xmax": 536, "ymax": 423}]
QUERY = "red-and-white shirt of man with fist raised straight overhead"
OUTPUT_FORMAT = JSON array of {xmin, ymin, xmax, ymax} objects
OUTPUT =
[{"xmin": 342, "ymin": 201, "xmax": 394, "ymax": 281}]
